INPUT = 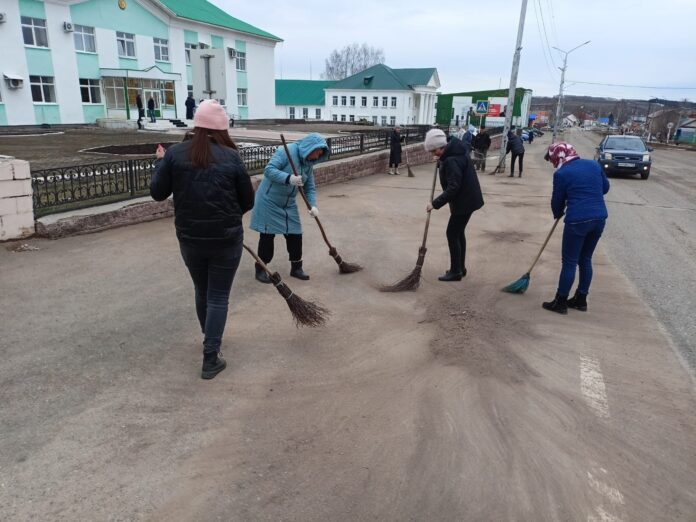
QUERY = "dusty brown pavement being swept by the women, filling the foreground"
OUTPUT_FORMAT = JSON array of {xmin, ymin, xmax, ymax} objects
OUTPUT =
[{"xmin": 0, "ymin": 140, "xmax": 696, "ymax": 521}]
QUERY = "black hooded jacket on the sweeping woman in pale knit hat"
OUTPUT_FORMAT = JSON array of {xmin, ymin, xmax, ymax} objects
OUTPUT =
[{"xmin": 433, "ymin": 138, "xmax": 483, "ymax": 215}]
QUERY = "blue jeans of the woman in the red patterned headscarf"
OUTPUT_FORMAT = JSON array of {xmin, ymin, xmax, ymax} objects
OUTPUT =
[{"xmin": 558, "ymin": 219, "xmax": 606, "ymax": 297}]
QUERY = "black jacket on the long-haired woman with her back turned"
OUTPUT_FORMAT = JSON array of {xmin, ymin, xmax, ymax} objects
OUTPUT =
[{"xmin": 150, "ymin": 141, "xmax": 254, "ymax": 246}]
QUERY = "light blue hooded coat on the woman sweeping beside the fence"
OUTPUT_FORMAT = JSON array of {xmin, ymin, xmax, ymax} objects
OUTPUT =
[{"xmin": 251, "ymin": 133, "xmax": 329, "ymax": 234}]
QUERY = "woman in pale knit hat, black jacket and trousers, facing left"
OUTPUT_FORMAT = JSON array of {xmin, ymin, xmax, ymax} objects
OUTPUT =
[{"xmin": 424, "ymin": 129, "xmax": 483, "ymax": 281}]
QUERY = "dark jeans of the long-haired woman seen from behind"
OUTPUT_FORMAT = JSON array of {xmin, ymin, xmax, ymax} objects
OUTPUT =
[{"xmin": 179, "ymin": 234, "xmax": 243, "ymax": 353}]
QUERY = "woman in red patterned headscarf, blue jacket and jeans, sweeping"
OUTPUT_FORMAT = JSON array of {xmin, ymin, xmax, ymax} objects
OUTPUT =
[{"xmin": 542, "ymin": 141, "xmax": 609, "ymax": 314}]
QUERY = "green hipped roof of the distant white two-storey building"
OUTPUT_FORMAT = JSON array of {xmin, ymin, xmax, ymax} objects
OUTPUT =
[{"xmin": 331, "ymin": 63, "xmax": 436, "ymax": 91}]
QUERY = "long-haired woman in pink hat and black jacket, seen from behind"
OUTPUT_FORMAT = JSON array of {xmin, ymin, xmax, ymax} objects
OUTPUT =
[{"xmin": 150, "ymin": 100, "xmax": 254, "ymax": 379}]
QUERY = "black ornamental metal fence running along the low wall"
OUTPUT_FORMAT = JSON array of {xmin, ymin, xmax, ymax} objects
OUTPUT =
[{"xmin": 31, "ymin": 126, "xmax": 428, "ymax": 217}]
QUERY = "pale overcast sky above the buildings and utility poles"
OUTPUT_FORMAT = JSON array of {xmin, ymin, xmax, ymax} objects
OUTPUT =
[{"xmin": 218, "ymin": 0, "xmax": 696, "ymax": 101}]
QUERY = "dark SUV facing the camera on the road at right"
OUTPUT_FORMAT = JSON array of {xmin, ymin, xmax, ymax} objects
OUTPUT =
[{"xmin": 595, "ymin": 135, "xmax": 653, "ymax": 179}]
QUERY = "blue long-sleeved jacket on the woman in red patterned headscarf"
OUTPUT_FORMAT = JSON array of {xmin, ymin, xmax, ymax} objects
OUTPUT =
[{"xmin": 551, "ymin": 159, "xmax": 609, "ymax": 223}]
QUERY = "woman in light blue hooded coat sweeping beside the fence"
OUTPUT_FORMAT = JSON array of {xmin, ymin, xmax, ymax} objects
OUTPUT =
[{"xmin": 250, "ymin": 132, "xmax": 329, "ymax": 283}]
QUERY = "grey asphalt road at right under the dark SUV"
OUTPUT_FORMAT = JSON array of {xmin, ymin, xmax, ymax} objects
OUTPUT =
[{"xmin": 566, "ymin": 131, "xmax": 696, "ymax": 378}]
